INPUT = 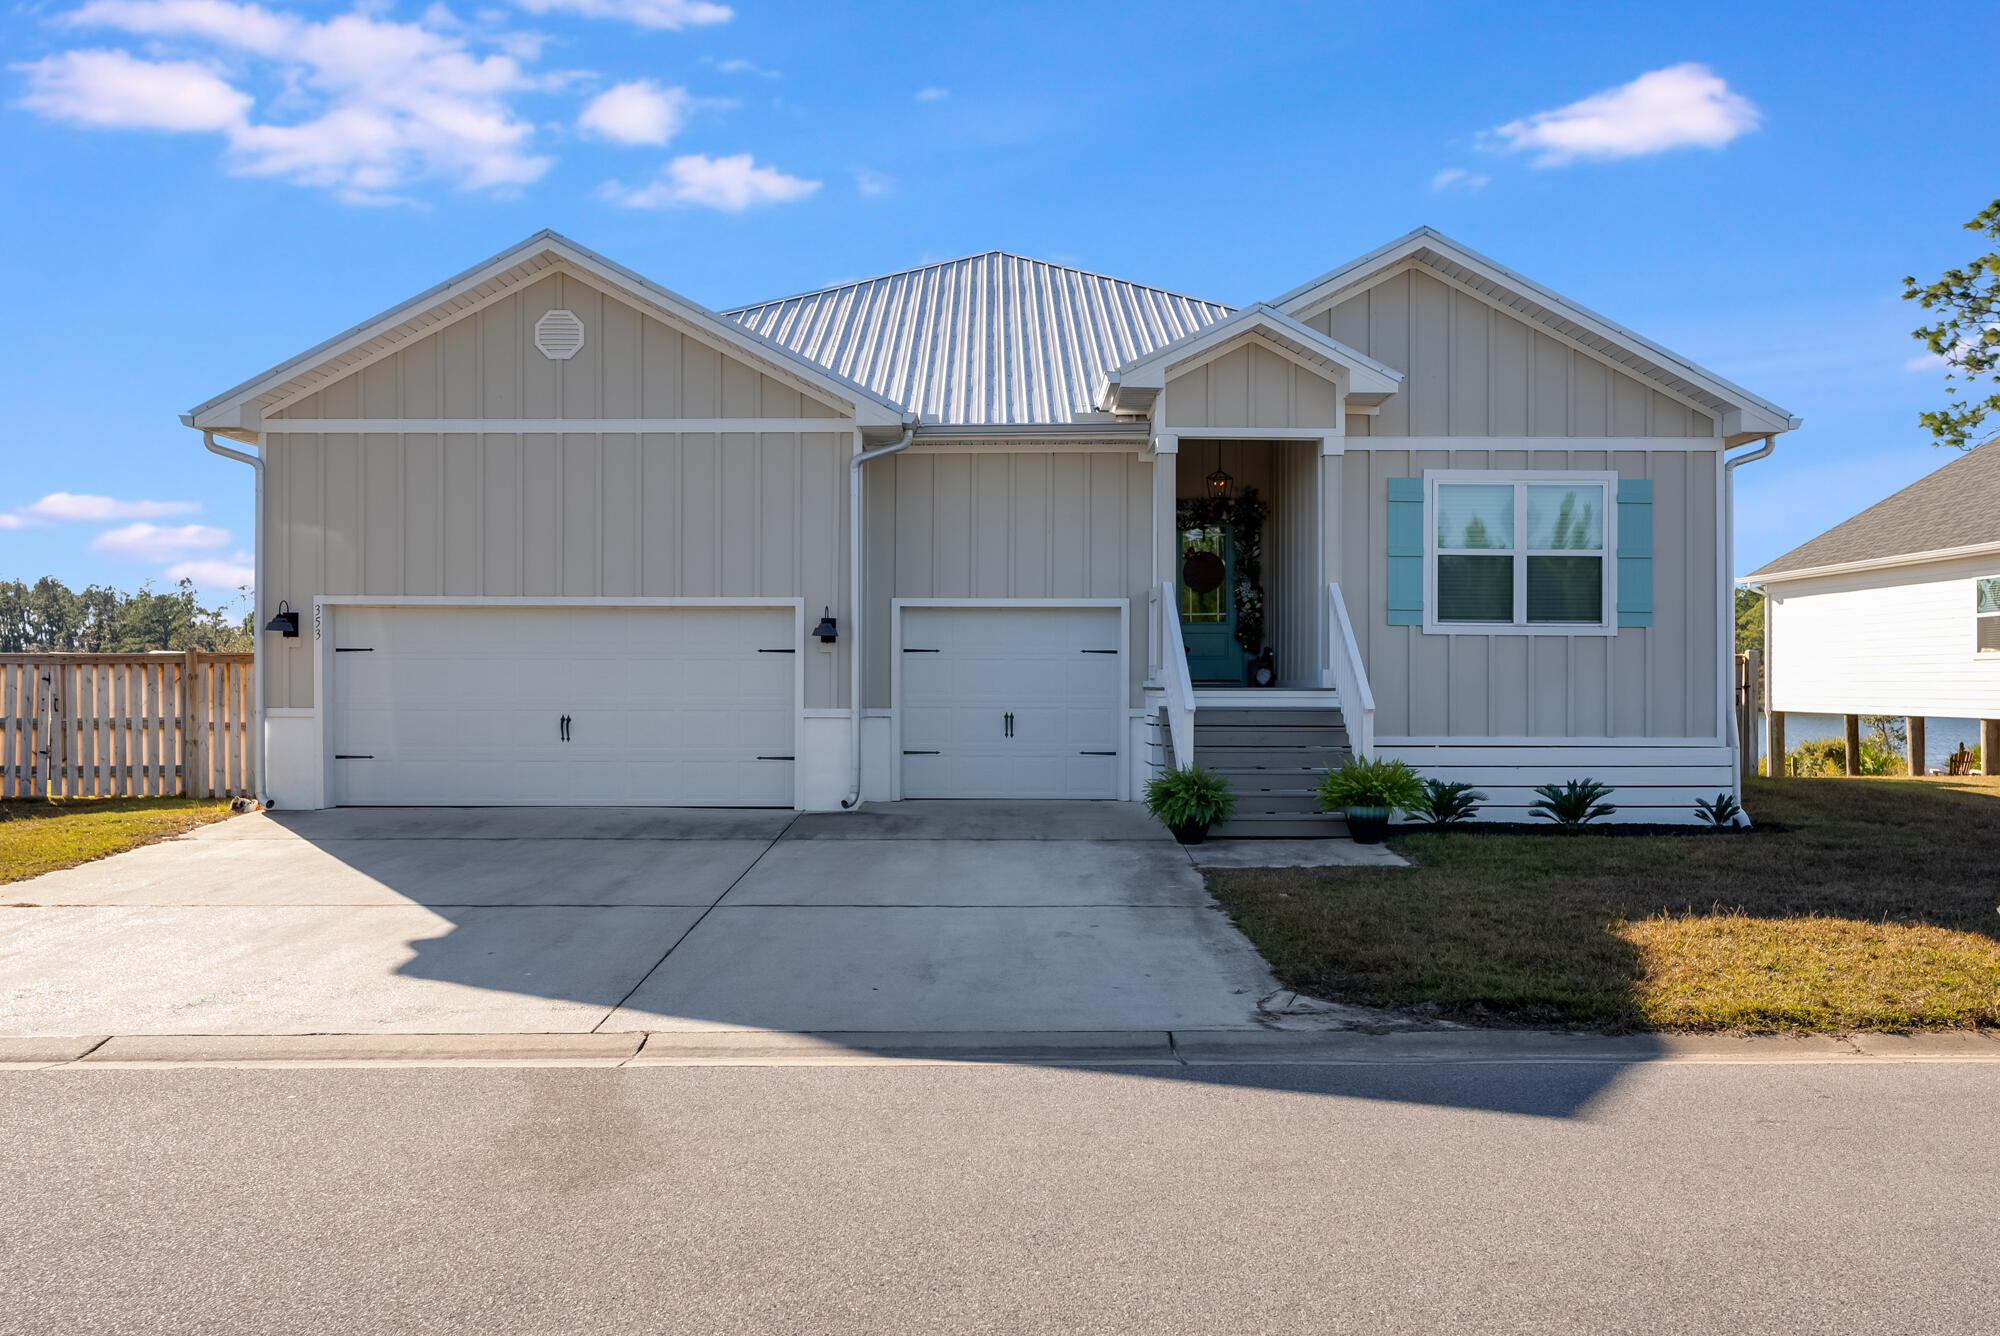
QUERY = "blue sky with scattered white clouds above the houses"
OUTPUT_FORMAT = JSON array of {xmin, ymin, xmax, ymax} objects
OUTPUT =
[{"xmin": 0, "ymin": 0, "xmax": 2000, "ymax": 596}]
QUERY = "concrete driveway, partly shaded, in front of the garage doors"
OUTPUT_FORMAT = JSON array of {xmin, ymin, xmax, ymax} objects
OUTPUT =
[{"xmin": 0, "ymin": 802, "xmax": 1276, "ymax": 1034}]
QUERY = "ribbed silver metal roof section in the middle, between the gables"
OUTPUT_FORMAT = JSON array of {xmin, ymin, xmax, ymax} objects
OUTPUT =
[{"xmin": 722, "ymin": 250, "xmax": 1234, "ymax": 424}]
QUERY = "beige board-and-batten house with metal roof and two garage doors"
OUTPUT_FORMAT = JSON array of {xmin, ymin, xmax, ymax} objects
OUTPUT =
[{"xmin": 182, "ymin": 228, "xmax": 1798, "ymax": 834}]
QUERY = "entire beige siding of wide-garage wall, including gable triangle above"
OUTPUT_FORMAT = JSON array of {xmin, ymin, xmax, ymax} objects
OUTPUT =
[{"xmin": 264, "ymin": 274, "xmax": 854, "ymax": 708}]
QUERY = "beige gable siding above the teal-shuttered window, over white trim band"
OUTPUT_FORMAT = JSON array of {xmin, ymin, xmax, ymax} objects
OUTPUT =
[{"xmin": 1304, "ymin": 270, "xmax": 1716, "ymax": 436}]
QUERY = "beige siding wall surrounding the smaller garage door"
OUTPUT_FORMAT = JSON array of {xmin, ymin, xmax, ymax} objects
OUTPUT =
[{"xmin": 866, "ymin": 446, "xmax": 1152, "ymax": 708}]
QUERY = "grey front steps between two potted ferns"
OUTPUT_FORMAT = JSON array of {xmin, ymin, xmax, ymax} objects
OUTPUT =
[{"xmin": 1168, "ymin": 692, "xmax": 1354, "ymax": 840}]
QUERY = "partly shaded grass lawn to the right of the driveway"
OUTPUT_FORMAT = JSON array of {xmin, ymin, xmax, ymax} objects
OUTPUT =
[{"xmin": 1208, "ymin": 778, "xmax": 2000, "ymax": 1032}]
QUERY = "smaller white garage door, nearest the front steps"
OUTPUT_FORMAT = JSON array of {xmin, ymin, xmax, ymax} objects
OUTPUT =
[{"xmin": 898, "ymin": 608, "xmax": 1126, "ymax": 798}]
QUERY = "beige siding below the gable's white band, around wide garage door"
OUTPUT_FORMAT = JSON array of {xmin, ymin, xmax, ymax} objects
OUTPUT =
[{"xmin": 264, "ymin": 432, "xmax": 852, "ymax": 708}]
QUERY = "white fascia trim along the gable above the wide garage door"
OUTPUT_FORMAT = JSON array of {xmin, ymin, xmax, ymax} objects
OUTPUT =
[{"xmin": 184, "ymin": 228, "xmax": 914, "ymax": 428}]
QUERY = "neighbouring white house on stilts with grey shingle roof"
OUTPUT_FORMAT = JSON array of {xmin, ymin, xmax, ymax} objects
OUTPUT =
[{"xmin": 1742, "ymin": 438, "xmax": 2000, "ymax": 772}]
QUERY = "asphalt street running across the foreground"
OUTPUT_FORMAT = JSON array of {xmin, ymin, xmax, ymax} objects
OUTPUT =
[{"xmin": 0, "ymin": 1062, "xmax": 2000, "ymax": 1336}]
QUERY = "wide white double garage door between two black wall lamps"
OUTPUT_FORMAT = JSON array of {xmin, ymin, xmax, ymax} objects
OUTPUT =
[{"xmin": 328, "ymin": 606, "xmax": 798, "ymax": 808}]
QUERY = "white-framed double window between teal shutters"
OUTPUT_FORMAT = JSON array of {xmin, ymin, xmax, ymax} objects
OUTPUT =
[{"xmin": 1426, "ymin": 472, "xmax": 1616, "ymax": 632}]
